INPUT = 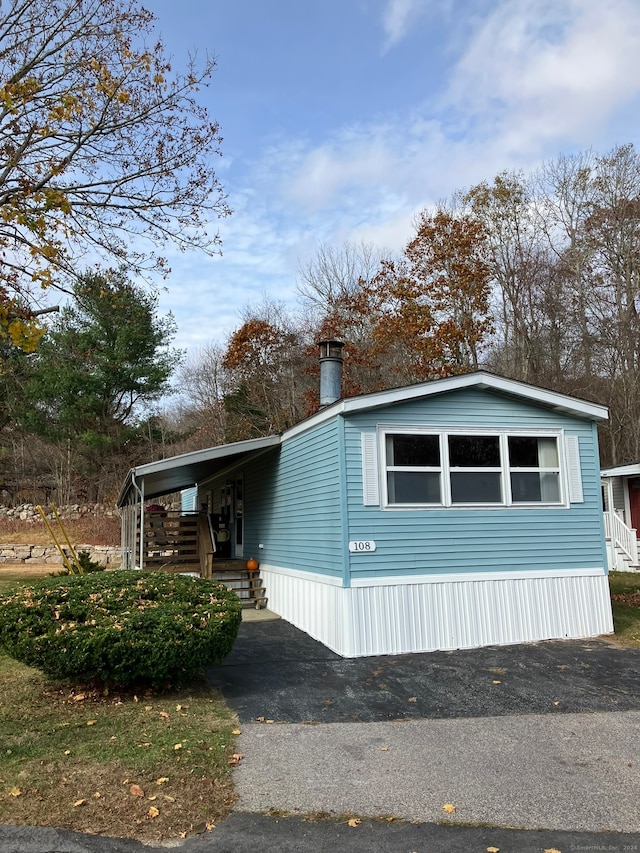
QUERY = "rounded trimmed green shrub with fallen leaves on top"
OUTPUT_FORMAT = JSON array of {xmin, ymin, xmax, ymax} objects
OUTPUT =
[{"xmin": 0, "ymin": 571, "xmax": 242, "ymax": 687}]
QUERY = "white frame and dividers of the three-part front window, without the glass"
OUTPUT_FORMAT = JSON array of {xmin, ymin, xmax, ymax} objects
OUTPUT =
[{"xmin": 377, "ymin": 424, "xmax": 570, "ymax": 511}]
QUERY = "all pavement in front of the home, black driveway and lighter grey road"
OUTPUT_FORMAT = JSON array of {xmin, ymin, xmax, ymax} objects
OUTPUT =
[{"xmin": 0, "ymin": 621, "xmax": 640, "ymax": 853}]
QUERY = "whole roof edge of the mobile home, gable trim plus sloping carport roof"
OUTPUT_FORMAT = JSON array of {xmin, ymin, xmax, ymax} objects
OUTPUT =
[{"xmin": 118, "ymin": 371, "xmax": 608, "ymax": 506}]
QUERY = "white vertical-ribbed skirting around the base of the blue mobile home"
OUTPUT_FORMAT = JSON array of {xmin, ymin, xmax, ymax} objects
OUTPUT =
[{"xmin": 260, "ymin": 564, "xmax": 613, "ymax": 657}]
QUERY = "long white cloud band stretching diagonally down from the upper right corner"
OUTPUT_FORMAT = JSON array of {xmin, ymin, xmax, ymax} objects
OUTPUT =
[{"xmin": 278, "ymin": 0, "xmax": 640, "ymax": 229}]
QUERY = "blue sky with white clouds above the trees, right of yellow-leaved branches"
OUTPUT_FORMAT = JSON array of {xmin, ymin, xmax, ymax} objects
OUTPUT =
[{"xmin": 143, "ymin": 0, "xmax": 640, "ymax": 352}]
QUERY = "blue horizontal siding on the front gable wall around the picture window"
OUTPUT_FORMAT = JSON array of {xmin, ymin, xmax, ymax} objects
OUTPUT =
[{"xmin": 345, "ymin": 389, "xmax": 606, "ymax": 578}]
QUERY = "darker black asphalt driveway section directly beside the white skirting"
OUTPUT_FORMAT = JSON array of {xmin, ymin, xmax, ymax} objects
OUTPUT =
[{"xmin": 208, "ymin": 620, "xmax": 640, "ymax": 723}]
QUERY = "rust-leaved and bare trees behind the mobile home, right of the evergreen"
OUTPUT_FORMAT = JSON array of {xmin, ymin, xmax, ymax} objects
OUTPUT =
[{"xmin": 176, "ymin": 140, "xmax": 640, "ymax": 472}]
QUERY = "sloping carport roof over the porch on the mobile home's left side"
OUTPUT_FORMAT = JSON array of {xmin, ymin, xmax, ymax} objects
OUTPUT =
[{"xmin": 118, "ymin": 435, "xmax": 281, "ymax": 506}]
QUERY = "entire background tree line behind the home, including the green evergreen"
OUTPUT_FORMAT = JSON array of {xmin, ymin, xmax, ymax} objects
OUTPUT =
[{"xmin": 0, "ymin": 145, "xmax": 640, "ymax": 502}]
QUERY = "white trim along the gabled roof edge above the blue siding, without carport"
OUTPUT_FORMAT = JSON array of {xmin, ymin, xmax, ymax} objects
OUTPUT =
[{"xmin": 282, "ymin": 371, "xmax": 609, "ymax": 441}]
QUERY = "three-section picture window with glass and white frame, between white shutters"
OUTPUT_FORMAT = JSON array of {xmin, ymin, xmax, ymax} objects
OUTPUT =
[{"xmin": 382, "ymin": 430, "xmax": 563, "ymax": 507}]
